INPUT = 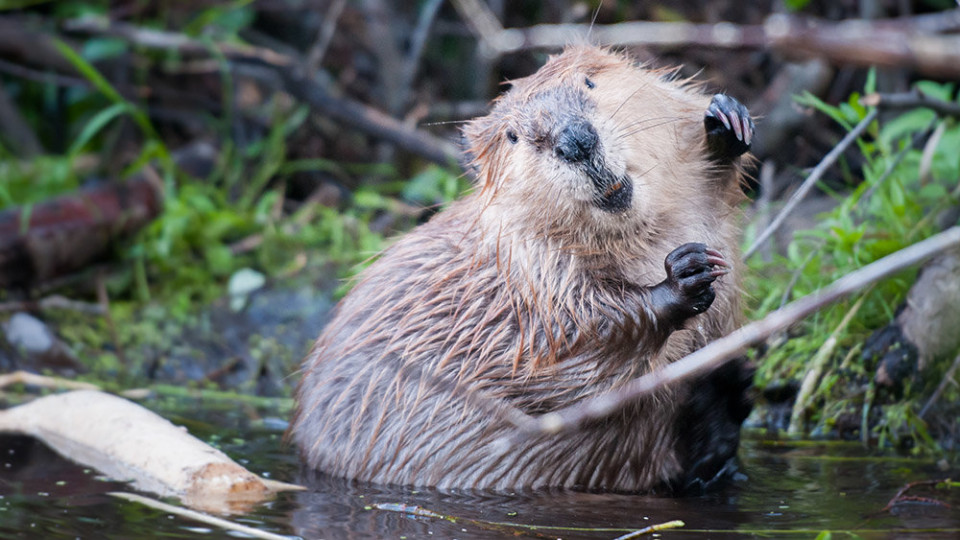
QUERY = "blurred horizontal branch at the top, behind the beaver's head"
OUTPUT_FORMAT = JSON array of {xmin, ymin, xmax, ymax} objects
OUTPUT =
[{"xmin": 454, "ymin": 0, "xmax": 960, "ymax": 78}]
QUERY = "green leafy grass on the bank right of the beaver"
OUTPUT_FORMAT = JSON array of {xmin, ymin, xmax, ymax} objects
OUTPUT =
[{"xmin": 746, "ymin": 71, "xmax": 960, "ymax": 451}]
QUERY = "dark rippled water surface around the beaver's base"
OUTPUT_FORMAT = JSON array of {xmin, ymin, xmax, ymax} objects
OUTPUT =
[{"xmin": 0, "ymin": 398, "xmax": 960, "ymax": 540}]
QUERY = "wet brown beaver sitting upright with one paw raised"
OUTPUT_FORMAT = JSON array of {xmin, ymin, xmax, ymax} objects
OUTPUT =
[{"xmin": 290, "ymin": 45, "xmax": 754, "ymax": 492}]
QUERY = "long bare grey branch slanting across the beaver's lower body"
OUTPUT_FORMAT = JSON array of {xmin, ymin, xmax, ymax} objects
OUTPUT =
[{"xmin": 503, "ymin": 226, "xmax": 960, "ymax": 438}]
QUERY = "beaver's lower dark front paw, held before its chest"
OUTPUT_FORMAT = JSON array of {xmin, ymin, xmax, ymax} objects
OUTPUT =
[{"xmin": 662, "ymin": 243, "xmax": 730, "ymax": 318}]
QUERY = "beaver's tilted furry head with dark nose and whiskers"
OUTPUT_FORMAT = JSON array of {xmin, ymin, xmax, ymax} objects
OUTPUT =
[{"xmin": 465, "ymin": 47, "xmax": 705, "ymax": 236}]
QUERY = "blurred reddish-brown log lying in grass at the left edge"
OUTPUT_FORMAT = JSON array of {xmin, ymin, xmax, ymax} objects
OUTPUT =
[{"xmin": 0, "ymin": 176, "xmax": 162, "ymax": 288}]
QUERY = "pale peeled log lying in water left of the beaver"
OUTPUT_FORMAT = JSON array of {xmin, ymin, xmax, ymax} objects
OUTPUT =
[{"xmin": 0, "ymin": 390, "xmax": 301, "ymax": 512}]
